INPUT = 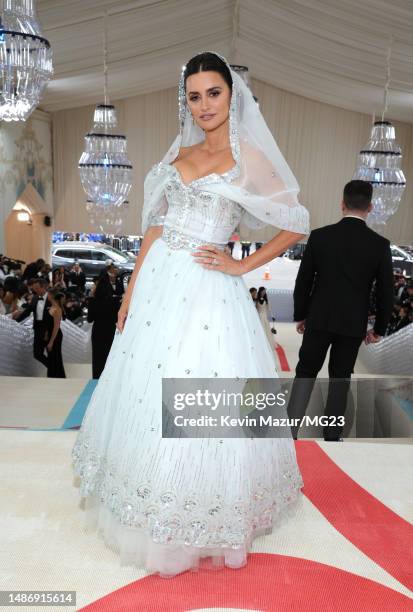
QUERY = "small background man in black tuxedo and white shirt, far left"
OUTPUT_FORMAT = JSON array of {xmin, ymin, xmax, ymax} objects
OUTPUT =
[{"xmin": 16, "ymin": 278, "xmax": 52, "ymax": 367}]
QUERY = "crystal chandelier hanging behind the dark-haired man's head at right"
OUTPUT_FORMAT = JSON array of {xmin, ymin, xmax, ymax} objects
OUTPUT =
[{"xmin": 353, "ymin": 38, "xmax": 406, "ymax": 231}]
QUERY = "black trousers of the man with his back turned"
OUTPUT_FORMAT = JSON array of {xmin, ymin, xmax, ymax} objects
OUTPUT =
[{"xmin": 287, "ymin": 329, "xmax": 363, "ymax": 439}]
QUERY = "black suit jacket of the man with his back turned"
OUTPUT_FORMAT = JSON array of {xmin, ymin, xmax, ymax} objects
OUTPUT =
[{"xmin": 294, "ymin": 217, "xmax": 394, "ymax": 337}]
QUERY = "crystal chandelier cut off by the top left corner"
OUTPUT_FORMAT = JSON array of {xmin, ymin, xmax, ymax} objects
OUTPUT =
[{"xmin": 0, "ymin": 0, "xmax": 53, "ymax": 121}]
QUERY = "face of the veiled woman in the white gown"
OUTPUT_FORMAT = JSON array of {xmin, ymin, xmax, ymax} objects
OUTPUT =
[{"xmin": 186, "ymin": 70, "xmax": 231, "ymax": 132}]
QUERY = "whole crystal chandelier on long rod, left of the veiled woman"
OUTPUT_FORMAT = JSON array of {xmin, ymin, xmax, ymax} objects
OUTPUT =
[{"xmin": 79, "ymin": 14, "xmax": 132, "ymax": 213}]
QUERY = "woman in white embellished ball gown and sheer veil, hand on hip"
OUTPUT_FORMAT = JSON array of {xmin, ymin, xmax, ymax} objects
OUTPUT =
[{"xmin": 72, "ymin": 53, "xmax": 309, "ymax": 576}]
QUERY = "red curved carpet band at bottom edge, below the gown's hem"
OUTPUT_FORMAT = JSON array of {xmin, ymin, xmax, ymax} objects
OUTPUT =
[{"xmin": 82, "ymin": 553, "xmax": 413, "ymax": 612}]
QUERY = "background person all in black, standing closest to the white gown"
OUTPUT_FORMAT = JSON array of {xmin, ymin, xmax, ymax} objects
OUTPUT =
[{"xmin": 87, "ymin": 270, "xmax": 120, "ymax": 378}]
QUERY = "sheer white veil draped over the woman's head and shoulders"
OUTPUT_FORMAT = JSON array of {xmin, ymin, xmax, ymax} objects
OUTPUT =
[{"xmin": 142, "ymin": 53, "xmax": 310, "ymax": 234}]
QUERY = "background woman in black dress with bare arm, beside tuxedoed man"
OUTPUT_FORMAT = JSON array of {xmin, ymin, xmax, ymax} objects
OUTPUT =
[{"xmin": 45, "ymin": 288, "xmax": 66, "ymax": 378}]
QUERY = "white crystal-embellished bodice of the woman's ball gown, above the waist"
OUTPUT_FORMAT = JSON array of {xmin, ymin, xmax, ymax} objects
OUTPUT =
[{"xmin": 162, "ymin": 166, "xmax": 243, "ymax": 248}]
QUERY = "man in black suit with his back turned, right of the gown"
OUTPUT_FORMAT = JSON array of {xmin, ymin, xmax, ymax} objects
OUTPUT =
[{"xmin": 287, "ymin": 181, "xmax": 394, "ymax": 441}]
